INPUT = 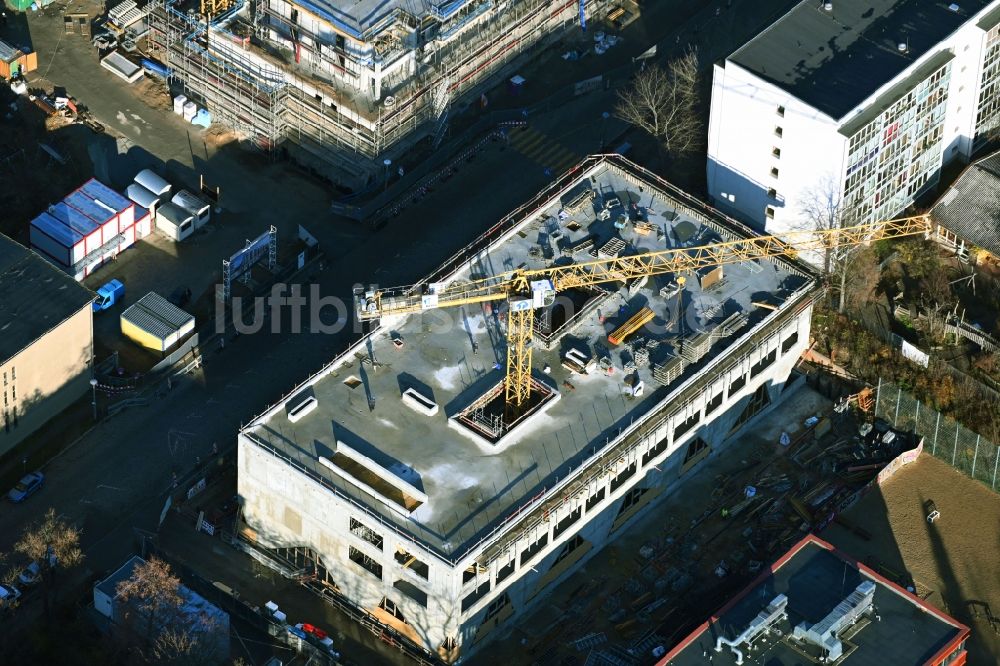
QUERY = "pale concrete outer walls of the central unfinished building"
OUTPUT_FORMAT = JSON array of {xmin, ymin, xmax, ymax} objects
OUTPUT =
[{"xmin": 237, "ymin": 307, "xmax": 812, "ymax": 654}]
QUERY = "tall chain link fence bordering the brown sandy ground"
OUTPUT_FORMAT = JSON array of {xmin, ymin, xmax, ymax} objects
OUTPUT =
[{"xmin": 875, "ymin": 380, "xmax": 1000, "ymax": 490}]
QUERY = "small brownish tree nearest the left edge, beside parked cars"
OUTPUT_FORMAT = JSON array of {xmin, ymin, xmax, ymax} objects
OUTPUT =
[{"xmin": 14, "ymin": 509, "xmax": 83, "ymax": 620}]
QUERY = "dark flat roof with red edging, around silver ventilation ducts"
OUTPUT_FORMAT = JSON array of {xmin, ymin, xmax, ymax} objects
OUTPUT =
[{"xmin": 666, "ymin": 536, "xmax": 967, "ymax": 666}]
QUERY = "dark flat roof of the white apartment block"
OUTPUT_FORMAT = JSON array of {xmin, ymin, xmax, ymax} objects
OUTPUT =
[{"xmin": 729, "ymin": 0, "xmax": 991, "ymax": 119}]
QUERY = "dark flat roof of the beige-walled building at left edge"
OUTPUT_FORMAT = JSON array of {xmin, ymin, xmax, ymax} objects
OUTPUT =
[{"xmin": 0, "ymin": 235, "xmax": 94, "ymax": 363}]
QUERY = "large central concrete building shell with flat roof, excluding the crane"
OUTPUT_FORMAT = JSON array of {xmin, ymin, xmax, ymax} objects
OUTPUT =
[{"xmin": 238, "ymin": 156, "xmax": 819, "ymax": 659}]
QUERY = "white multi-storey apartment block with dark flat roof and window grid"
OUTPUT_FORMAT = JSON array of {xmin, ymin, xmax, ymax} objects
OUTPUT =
[{"xmin": 708, "ymin": 0, "xmax": 1000, "ymax": 234}]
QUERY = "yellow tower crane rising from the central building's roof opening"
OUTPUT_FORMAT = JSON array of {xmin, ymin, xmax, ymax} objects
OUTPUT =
[{"xmin": 354, "ymin": 215, "xmax": 932, "ymax": 418}]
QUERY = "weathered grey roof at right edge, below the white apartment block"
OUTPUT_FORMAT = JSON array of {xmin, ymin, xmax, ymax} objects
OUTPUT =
[{"xmin": 931, "ymin": 152, "xmax": 1000, "ymax": 255}]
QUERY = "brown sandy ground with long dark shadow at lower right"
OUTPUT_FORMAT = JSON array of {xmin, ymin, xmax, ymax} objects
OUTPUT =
[{"xmin": 821, "ymin": 454, "xmax": 1000, "ymax": 666}]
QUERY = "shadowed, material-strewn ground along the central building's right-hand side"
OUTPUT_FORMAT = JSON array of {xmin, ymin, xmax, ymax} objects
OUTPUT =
[{"xmin": 480, "ymin": 385, "xmax": 840, "ymax": 665}]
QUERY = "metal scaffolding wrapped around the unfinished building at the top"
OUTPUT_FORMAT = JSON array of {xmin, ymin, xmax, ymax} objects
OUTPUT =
[{"xmin": 150, "ymin": 0, "xmax": 606, "ymax": 178}]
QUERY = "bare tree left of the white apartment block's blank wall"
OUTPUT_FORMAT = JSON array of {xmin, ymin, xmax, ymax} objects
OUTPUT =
[{"xmin": 615, "ymin": 50, "xmax": 702, "ymax": 155}]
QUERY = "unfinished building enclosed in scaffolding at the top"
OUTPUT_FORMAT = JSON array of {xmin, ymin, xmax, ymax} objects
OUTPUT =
[{"xmin": 150, "ymin": 0, "xmax": 623, "ymax": 186}]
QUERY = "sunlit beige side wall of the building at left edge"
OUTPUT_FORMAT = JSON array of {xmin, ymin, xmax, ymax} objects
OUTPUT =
[{"xmin": 0, "ymin": 303, "xmax": 94, "ymax": 454}]
